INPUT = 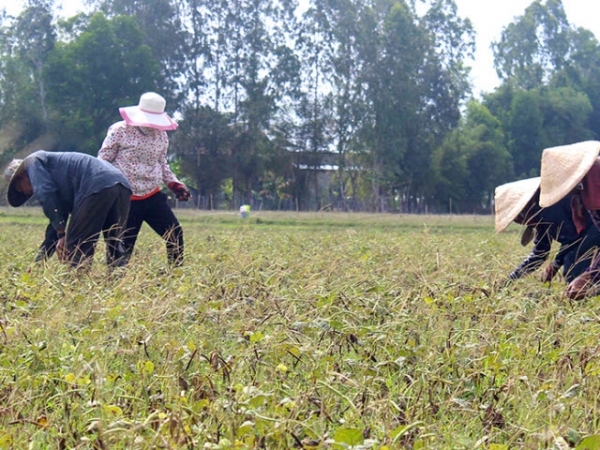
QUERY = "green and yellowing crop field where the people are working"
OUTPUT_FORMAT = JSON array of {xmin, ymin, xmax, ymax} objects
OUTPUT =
[{"xmin": 0, "ymin": 208, "xmax": 600, "ymax": 450}]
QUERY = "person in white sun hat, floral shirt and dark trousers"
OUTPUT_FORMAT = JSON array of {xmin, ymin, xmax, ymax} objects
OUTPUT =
[{"xmin": 98, "ymin": 92, "xmax": 190, "ymax": 266}]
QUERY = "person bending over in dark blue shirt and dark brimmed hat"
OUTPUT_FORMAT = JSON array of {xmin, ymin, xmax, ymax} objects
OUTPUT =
[{"xmin": 4, "ymin": 150, "xmax": 131, "ymax": 267}]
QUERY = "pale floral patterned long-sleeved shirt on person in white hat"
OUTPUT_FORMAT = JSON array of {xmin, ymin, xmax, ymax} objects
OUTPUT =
[{"xmin": 98, "ymin": 121, "xmax": 179, "ymax": 198}]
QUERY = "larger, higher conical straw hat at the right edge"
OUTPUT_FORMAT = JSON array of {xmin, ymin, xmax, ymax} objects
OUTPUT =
[{"xmin": 540, "ymin": 141, "xmax": 600, "ymax": 208}]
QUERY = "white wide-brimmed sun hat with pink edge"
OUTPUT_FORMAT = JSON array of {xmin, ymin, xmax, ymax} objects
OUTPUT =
[{"xmin": 119, "ymin": 92, "xmax": 177, "ymax": 131}]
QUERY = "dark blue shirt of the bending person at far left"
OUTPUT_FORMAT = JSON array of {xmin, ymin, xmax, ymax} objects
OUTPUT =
[{"xmin": 23, "ymin": 150, "xmax": 131, "ymax": 234}]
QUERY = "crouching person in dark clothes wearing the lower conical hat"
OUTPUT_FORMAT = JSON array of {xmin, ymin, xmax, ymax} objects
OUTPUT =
[{"xmin": 495, "ymin": 177, "xmax": 600, "ymax": 282}]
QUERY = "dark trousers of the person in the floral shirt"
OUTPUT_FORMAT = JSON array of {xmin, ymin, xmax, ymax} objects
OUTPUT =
[{"xmin": 123, "ymin": 192, "xmax": 183, "ymax": 266}]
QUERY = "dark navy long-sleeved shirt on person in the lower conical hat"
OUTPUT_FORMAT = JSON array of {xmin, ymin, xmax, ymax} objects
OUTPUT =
[{"xmin": 509, "ymin": 196, "xmax": 594, "ymax": 280}]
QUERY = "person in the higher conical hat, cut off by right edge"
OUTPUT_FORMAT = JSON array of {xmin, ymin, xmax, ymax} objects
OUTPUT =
[{"xmin": 540, "ymin": 141, "xmax": 600, "ymax": 300}]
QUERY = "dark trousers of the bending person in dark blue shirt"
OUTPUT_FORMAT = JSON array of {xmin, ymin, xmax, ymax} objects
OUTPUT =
[{"xmin": 66, "ymin": 184, "xmax": 131, "ymax": 267}]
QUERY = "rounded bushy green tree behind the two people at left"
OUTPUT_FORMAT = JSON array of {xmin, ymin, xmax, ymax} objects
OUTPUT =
[{"xmin": 45, "ymin": 13, "xmax": 162, "ymax": 154}]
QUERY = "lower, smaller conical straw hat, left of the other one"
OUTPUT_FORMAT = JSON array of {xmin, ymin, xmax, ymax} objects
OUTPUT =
[{"xmin": 494, "ymin": 177, "xmax": 540, "ymax": 233}]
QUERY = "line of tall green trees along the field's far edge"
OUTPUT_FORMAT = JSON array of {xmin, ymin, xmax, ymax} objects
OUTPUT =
[{"xmin": 0, "ymin": 0, "xmax": 600, "ymax": 213}]
